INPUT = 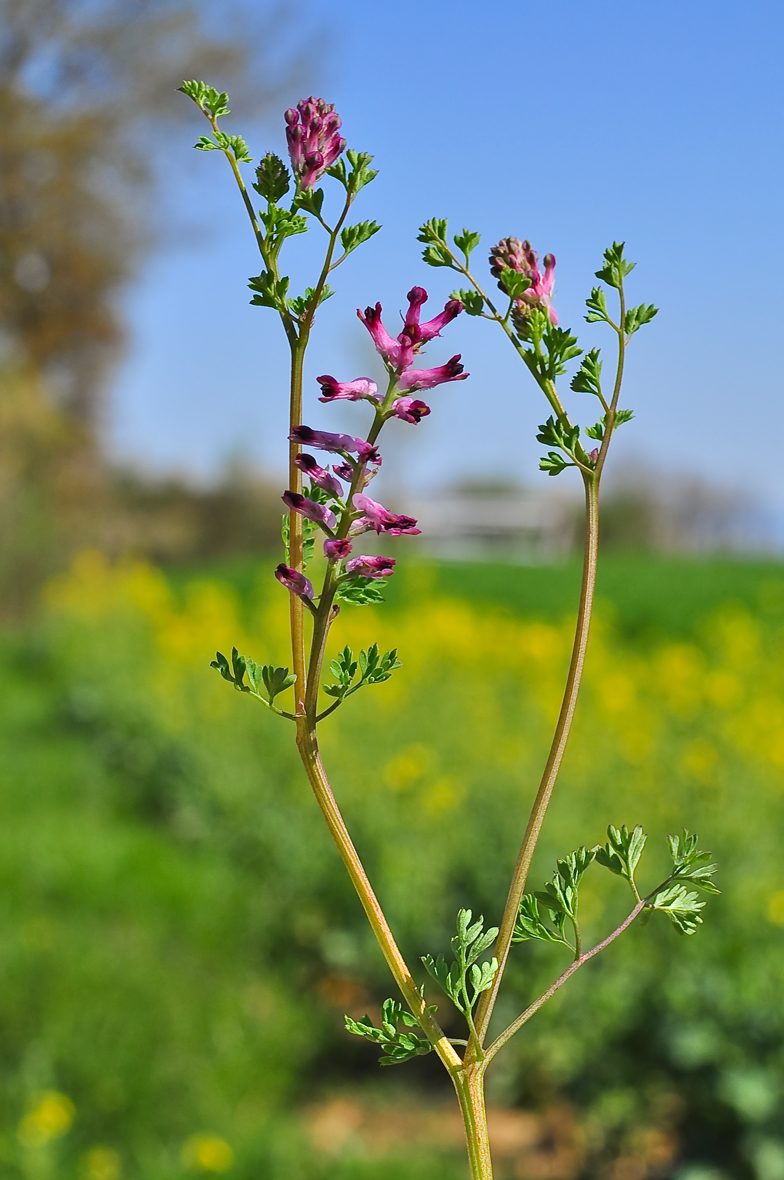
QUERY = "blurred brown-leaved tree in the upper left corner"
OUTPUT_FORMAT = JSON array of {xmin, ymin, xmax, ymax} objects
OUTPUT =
[{"xmin": 0, "ymin": 0, "xmax": 306, "ymax": 427}]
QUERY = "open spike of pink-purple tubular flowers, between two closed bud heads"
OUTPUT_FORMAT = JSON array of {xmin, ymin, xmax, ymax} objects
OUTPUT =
[{"xmin": 275, "ymin": 283, "xmax": 468, "ymax": 604}]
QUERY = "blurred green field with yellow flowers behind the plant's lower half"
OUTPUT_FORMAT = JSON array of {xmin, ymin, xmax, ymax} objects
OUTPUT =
[{"xmin": 0, "ymin": 555, "xmax": 784, "ymax": 1180}]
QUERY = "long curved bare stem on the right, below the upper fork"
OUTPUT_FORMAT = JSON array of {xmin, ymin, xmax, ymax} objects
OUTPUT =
[{"xmin": 469, "ymin": 472, "xmax": 599, "ymax": 1051}]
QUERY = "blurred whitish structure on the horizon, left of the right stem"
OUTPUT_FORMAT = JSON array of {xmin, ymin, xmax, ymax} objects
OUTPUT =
[{"xmin": 410, "ymin": 485, "xmax": 580, "ymax": 565}]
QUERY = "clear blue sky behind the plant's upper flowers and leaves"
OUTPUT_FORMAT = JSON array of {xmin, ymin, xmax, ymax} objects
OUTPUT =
[{"xmin": 109, "ymin": 0, "xmax": 784, "ymax": 514}]
